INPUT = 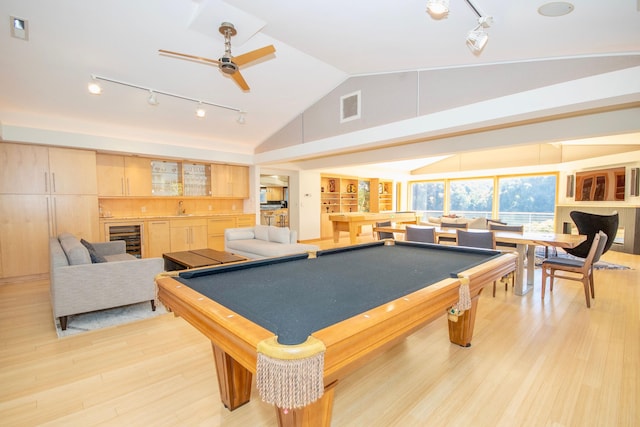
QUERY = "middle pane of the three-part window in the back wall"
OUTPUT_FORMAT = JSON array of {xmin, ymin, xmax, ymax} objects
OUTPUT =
[{"xmin": 449, "ymin": 178, "xmax": 493, "ymax": 218}]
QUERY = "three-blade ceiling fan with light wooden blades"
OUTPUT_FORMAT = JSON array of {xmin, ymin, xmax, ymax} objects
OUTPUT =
[{"xmin": 159, "ymin": 22, "xmax": 276, "ymax": 91}]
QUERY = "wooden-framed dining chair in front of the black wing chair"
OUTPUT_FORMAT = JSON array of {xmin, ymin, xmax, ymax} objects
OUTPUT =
[{"xmin": 542, "ymin": 231, "xmax": 607, "ymax": 308}]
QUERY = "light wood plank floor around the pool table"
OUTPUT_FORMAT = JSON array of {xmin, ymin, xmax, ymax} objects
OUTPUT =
[{"xmin": 0, "ymin": 237, "xmax": 640, "ymax": 427}]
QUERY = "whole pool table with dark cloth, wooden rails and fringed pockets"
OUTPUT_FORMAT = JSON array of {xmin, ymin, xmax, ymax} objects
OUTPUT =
[{"xmin": 156, "ymin": 241, "xmax": 516, "ymax": 426}]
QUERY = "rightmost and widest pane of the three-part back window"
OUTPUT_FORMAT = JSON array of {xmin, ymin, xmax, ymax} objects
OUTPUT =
[{"xmin": 498, "ymin": 175, "xmax": 556, "ymax": 232}]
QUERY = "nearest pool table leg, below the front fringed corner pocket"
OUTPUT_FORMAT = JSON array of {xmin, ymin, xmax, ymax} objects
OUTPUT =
[{"xmin": 276, "ymin": 381, "xmax": 338, "ymax": 427}]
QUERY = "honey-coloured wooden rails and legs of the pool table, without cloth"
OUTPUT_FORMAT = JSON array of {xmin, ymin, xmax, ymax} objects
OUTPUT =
[{"xmin": 156, "ymin": 254, "xmax": 516, "ymax": 426}]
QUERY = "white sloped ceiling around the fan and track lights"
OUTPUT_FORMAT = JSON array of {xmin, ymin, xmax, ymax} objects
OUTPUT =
[{"xmin": 0, "ymin": 0, "xmax": 640, "ymax": 172}]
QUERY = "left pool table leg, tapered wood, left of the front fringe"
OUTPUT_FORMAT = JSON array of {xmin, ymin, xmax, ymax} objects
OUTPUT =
[{"xmin": 211, "ymin": 342, "xmax": 252, "ymax": 411}]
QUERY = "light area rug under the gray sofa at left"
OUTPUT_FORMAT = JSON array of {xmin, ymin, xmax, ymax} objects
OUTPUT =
[{"xmin": 56, "ymin": 301, "xmax": 167, "ymax": 338}]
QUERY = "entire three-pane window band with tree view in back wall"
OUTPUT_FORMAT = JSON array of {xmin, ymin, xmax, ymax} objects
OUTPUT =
[{"xmin": 409, "ymin": 174, "xmax": 557, "ymax": 232}]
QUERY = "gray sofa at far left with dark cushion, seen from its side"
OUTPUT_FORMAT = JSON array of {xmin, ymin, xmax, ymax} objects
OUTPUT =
[{"xmin": 49, "ymin": 233, "xmax": 163, "ymax": 330}]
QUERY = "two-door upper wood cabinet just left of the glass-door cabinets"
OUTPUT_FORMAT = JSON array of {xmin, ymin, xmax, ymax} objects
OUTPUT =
[{"xmin": 96, "ymin": 154, "xmax": 151, "ymax": 197}]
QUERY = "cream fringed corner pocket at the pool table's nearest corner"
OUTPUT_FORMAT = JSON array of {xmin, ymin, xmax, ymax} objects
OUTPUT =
[{"xmin": 256, "ymin": 337, "xmax": 325, "ymax": 409}]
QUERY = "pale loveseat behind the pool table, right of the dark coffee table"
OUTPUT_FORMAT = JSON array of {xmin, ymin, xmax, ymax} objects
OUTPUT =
[{"xmin": 224, "ymin": 225, "xmax": 320, "ymax": 259}]
